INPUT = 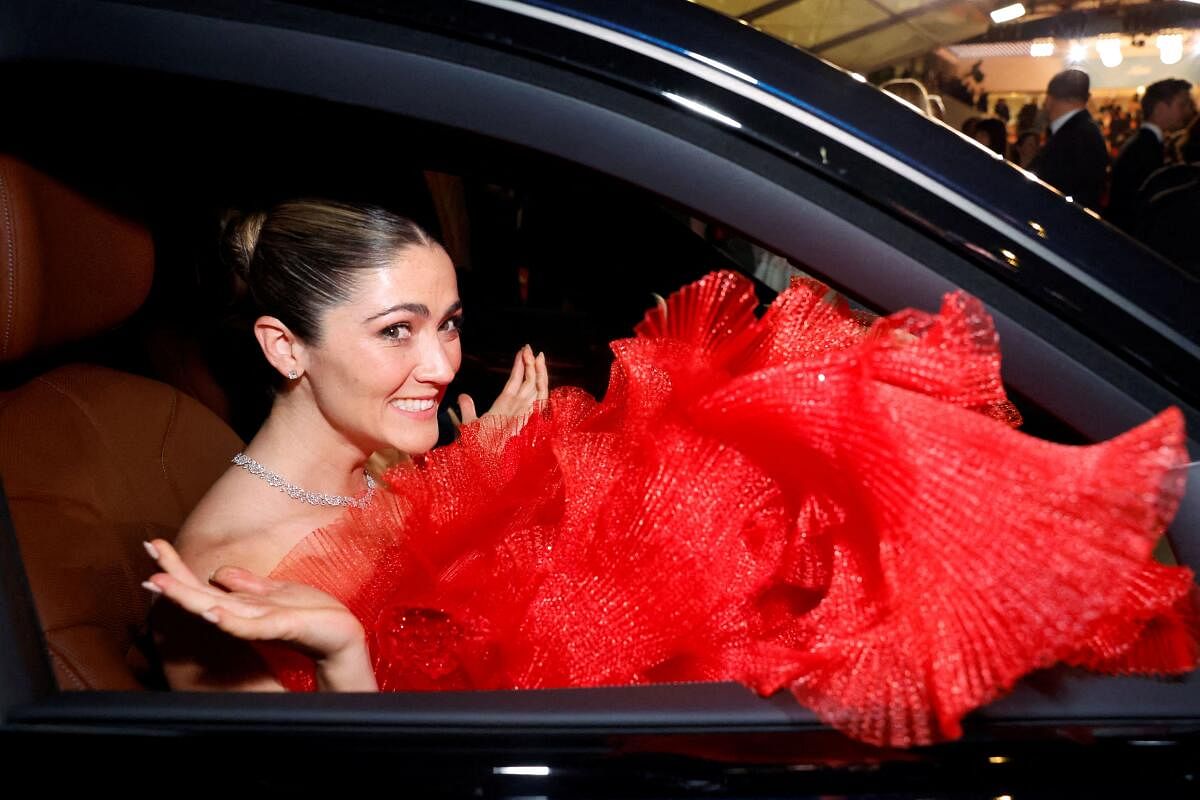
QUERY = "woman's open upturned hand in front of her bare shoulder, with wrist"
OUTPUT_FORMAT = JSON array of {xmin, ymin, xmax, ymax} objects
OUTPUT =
[{"xmin": 142, "ymin": 539, "xmax": 377, "ymax": 691}]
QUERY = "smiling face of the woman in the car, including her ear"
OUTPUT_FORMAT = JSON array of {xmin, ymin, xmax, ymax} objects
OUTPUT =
[{"xmin": 305, "ymin": 246, "xmax": 462, "ymax": 453}]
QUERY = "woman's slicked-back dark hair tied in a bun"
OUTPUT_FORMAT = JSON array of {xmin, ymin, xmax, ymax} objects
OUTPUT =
[{"xmin": 223, "ymin": 199, "xmax": 439, "ymax": 344}]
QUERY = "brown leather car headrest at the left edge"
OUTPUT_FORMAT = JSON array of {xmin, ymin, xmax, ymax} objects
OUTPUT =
[{"xmin": 0, "ymin": 154, "xmax": 154, "ymax": 363}]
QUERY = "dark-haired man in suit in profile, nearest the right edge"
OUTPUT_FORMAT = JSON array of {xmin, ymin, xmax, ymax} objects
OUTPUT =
[{"xmin": 1104, "ymin": 78, "xmax": 1195, "ymax": 233}]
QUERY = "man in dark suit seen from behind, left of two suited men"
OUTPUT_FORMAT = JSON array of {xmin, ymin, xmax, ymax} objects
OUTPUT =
[{"xmin": 1030, "ymin": 70, "xmax": 1109, "ymax": 209}]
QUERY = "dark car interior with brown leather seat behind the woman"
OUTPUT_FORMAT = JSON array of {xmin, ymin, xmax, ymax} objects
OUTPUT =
[{"xmin": 0, "ymin": 70, "xmax": 792, "ymax": 690}]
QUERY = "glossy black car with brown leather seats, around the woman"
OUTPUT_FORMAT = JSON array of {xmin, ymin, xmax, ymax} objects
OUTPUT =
[{"xmin": 0, "ymin": 0, "xmax": 1200, "ymax": 798}]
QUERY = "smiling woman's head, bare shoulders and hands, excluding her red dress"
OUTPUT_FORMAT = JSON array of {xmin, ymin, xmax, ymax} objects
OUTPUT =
[{"xmin": 145, "ymin": 200, "xmax": 547, "ymax": 691}]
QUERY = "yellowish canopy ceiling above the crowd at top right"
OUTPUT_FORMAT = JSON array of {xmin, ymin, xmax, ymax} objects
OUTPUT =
[{"xmin": 695, "ymin": 0, "xmax": 1200, "ymax": 74}]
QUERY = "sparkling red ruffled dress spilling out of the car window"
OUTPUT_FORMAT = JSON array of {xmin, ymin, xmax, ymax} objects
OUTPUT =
[{"xmin": 269, "ymin": 272, "xmax": 1198, "ymax": 746}]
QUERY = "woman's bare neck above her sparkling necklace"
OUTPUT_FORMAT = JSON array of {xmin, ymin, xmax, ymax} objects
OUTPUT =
[{"xmin": 245, "ymin": 390, "xmax": 370, "ymax": 495}]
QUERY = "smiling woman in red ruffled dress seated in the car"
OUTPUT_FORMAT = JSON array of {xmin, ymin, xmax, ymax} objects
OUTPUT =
[{"xmin": 149, "ymin": 201, "xmax": 1200, "ymax": 745}]
